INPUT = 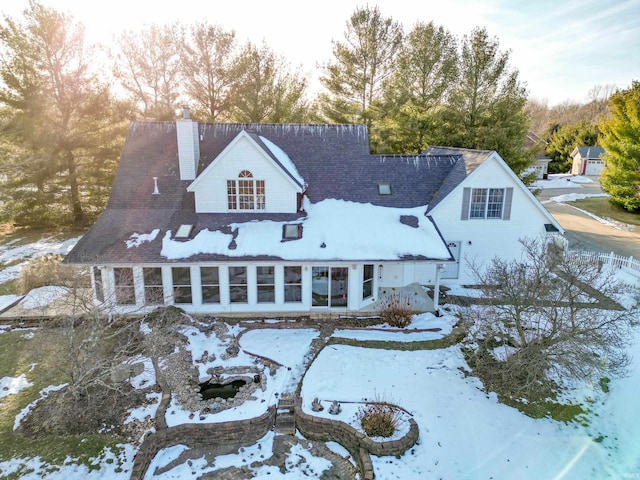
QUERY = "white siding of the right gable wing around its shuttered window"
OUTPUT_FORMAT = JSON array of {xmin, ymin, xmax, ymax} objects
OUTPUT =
[{"xmin": 431, "ymin": 157, "xmax": 549, "ymax": 285}]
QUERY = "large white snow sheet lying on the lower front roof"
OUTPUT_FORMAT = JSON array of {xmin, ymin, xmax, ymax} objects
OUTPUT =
[{"xmin": 159, "ymin": 200, "xmax": 451, "ymax": 261}]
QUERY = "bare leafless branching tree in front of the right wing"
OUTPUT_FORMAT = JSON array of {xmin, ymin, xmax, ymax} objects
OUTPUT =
[{"xmin": 463, "ymin": 239, "xmax": 638, "ymax": 400}]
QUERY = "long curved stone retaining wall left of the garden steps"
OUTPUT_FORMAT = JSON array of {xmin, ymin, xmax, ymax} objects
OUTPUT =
[{"xmin": 131, "ymin": 406, "xmax": 276, "ymax": 480}]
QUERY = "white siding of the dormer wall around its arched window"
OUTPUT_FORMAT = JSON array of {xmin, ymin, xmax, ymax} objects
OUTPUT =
[{"xmin": 195, "ymin": 137, "xmax": 298, "ymax": 213}]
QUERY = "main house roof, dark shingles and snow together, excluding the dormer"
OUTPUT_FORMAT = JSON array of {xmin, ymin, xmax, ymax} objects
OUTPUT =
[{"xmin": 65, "ymin": 122, "xmax": 464, "ymax": 264}]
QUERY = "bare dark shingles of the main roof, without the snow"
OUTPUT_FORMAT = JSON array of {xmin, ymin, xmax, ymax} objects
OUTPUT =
[{"xmin": 65, "ymin": 122, "xmax": 464, "ymax": 263}]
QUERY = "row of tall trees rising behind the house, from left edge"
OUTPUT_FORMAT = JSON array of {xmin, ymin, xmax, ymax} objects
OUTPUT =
[{"xmin": 0, "ymin": 0, "xmax": 636, "ymax": 227}]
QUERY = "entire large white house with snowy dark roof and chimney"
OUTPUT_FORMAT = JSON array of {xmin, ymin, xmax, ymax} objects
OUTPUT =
[{"xmin": 65, "ymin": 111, "xmax": 562, "ymax": 313}]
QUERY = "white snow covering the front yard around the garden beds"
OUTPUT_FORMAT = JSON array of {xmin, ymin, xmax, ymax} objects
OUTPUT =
[{"xmin": 0, "ymin": 300, "xmax": 640, "ymax": 480}]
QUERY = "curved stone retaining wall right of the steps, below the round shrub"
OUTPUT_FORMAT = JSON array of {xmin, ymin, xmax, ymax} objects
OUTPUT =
[{"xmin": 295, "ymin": 398, "xmax": 420, "ymax": 480}]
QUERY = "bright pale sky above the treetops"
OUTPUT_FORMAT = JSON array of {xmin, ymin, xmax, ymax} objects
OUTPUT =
[{"xmin": 0, "ymin": 0, "xmax": 640, "ymax": 106}]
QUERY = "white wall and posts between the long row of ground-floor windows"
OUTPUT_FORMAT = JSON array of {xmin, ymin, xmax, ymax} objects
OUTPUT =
[{"xmin": 92, "ymin": 262, "xmax": 384, "ymax": 314}]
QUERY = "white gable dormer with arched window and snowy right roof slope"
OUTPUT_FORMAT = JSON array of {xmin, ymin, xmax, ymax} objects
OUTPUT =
[{"xmin": 187, "ymin": 130, "xmax": 305, "ymax": 214}]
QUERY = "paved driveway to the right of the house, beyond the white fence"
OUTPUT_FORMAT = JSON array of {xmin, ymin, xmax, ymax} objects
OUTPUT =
[{"xmin": 537, "ymin": 183, "xmax": 640, "ymax": 259}]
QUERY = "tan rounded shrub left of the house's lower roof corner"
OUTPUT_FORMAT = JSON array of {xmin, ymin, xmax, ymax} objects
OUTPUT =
[{"xmin": 18, "ymin": 253, "xmax": 78, "ymax": 295}]
